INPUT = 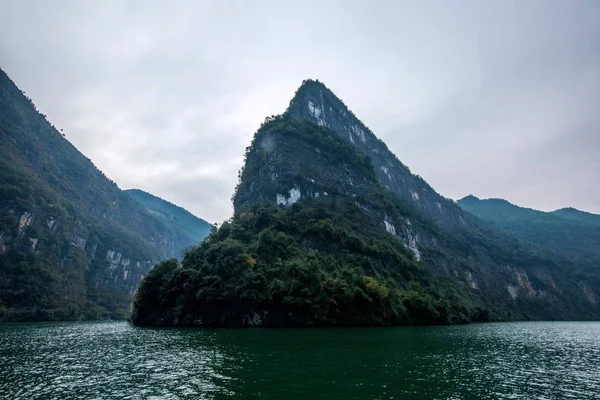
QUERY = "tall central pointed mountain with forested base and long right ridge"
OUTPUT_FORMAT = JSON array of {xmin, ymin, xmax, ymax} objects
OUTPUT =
[{"xmin": 132, "ymin": 80, "xmax": 600, "ymax": 326}]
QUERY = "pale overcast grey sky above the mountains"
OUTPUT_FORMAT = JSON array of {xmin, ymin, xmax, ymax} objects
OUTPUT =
[{"xmin": 0, "ymin": 0, "xmax": 600, "ymax": 222}]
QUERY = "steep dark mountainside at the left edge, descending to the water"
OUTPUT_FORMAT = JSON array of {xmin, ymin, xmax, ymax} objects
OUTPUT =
[{"xmin": 0, "ymin": 70, "xmax": 205, "ymax": 321}]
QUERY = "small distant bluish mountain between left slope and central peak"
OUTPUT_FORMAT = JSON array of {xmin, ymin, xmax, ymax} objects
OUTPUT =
[{"xmin": 125, "ymin": 189, "xmax": 212, "ymax": 253}]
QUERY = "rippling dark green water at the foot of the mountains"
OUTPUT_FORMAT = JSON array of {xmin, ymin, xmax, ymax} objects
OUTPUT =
[{"xmin": 0, "ymin": 322, "xmax": 600, "ymax": 399}]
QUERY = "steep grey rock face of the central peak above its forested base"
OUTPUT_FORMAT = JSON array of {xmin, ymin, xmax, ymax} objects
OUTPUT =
[{"xmin": 234, "ymin": 81, "xmax": 600, "ymax": 319}]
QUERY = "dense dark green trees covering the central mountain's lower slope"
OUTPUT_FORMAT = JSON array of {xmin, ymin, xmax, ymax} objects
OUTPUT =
[{"xmin": 132, "ymin": 201, "xmax": 497, "ymax": 326}]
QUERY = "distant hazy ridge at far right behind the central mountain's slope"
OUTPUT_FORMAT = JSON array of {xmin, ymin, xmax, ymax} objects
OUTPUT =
[{"xmin": 458, "ymin": 196, "xmax": 600, "ymax": 274}]
